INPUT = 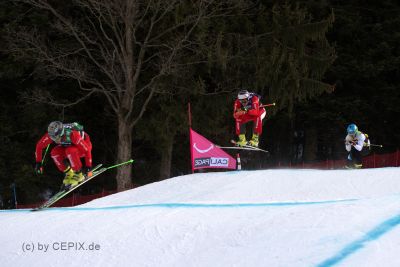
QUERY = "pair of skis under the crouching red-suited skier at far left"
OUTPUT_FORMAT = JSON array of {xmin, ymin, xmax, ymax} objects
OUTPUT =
[{"xmin": 32, "ymin": 159, "xmax": 133, "ymax": 211}]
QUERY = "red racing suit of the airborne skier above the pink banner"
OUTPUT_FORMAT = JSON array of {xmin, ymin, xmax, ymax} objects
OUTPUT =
[{"xmin": 233, "ymin": 94, "xmax": 266, "ymax": 135}]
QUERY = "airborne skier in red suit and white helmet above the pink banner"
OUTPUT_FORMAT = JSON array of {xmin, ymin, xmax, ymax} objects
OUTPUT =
[{"xmin": 233, "ymin": 90, "xmax": 266, "ymax": 147}]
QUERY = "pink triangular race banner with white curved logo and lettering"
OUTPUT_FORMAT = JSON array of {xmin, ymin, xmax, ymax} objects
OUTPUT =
[{"xmin": 190, "ymin": 129, "xmax": 236, "ymax": 171}]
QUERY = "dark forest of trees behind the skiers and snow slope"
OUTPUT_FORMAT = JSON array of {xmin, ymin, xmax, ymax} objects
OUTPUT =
[{"xmin": 0, "ymin": 0, "xmax": 400, "ymax": 207}]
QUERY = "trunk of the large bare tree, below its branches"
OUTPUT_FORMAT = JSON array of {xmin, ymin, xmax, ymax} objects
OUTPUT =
[{"xmin": 116, "ymin": 117, "xmax": 132, "ymax": 191}]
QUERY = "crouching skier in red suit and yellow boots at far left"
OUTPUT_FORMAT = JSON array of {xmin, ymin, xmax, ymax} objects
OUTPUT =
[{"xmin": 35, "ymin": 121, "xmax": 92, "ymax": 188}]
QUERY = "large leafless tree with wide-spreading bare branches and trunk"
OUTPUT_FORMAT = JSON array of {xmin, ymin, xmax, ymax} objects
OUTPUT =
[{"xmin": 5, "ymin": 0, "xmax": 250, "ymax": 192}]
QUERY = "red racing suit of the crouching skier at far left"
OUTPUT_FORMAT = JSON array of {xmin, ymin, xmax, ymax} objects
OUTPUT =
[{"xmin": 35, "ymin": 130, "xmax": 92, "ymax": 172}]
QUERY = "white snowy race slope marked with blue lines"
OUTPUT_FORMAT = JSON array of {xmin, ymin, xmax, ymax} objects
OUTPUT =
[{"xmin": 0, "ymin": 168, "xmax": 400, "ymax": 267}]
